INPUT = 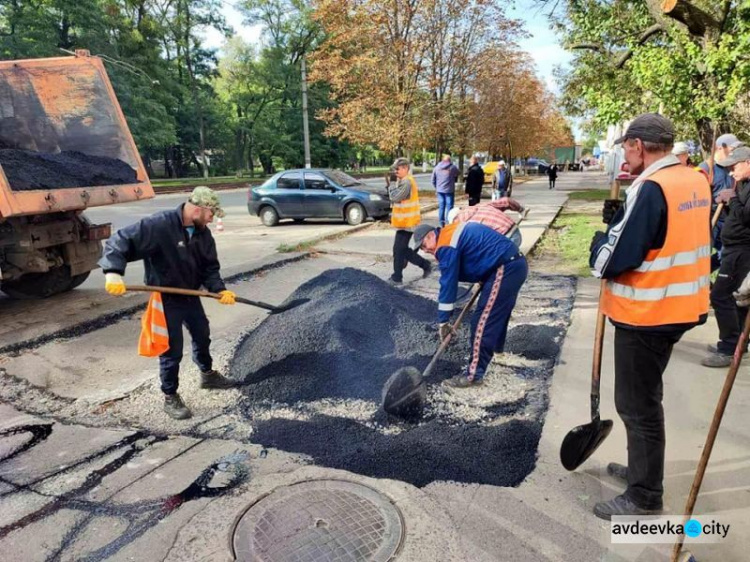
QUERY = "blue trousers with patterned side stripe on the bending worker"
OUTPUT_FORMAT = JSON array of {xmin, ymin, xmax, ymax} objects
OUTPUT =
[{"xmin": 466, "ymin": 257, "xmax": 529, "ymax": 380}]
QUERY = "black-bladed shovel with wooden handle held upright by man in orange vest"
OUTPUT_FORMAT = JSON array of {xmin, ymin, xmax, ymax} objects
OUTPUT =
[{"xmin": 560, "ymin": 181, "xmax": 620, "ymax": 470}]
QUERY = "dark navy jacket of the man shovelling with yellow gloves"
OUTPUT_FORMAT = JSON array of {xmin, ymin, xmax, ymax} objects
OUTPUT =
[{"xmin": 99, "ymin": 204, "xmax": 226, "ymax": 293}]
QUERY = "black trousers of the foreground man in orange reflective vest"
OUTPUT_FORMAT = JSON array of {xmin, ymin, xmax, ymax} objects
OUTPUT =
[{"xmin": 615, "ymin": 327, "xmax": 682, "ymax": 509}]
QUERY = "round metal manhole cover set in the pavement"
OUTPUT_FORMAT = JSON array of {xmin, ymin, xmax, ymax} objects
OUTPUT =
[{"xmin": 232, "ymin": 480, "xmax": 404, "ymax": 562}]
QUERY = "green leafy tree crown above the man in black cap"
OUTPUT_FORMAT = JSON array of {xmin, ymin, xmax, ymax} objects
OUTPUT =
[{"xmin": 553, "ymin": 0, "xmax": 750, "ymax": 149}]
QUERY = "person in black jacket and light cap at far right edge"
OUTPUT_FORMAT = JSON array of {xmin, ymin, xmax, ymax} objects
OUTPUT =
[{"xmin": 701, "ymin": 146, "xmax": 750, "ymax": 367}]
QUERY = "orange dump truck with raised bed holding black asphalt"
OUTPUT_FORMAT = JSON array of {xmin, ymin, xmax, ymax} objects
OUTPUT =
[{"xmin": 0, "ymin": 50, "xmax": 154, "ymax": 298}]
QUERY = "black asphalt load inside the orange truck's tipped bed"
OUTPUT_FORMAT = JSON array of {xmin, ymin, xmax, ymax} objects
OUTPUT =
[{"xmin": 0, "ymin": 149, "xmax": 138, "ymax": 191}]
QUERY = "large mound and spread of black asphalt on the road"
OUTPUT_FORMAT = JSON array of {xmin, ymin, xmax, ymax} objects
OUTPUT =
[{"xmin": 230, "ymin": 268, "xmax": 572, "ymax": 487}]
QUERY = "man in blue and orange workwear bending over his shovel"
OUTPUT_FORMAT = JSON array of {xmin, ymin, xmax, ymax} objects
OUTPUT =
[{"xmin": 411, "ymin": 222, "xmax": 529, "ymax": 388}]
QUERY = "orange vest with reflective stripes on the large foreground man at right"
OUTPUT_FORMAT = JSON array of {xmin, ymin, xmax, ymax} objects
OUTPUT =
[{"xmin": 601, "ymin": 166, "xmax": 711, "ymax": 326}]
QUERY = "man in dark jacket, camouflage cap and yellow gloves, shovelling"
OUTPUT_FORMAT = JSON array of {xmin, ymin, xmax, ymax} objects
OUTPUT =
[{"xmin": 99, "ymin": 187, "xmax": 235, "ymax": 419}]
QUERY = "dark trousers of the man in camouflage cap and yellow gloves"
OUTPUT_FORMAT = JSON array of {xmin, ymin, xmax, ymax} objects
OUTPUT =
[{"xmin": 159, "ymin": 295, "xmax": 213, "ymax": 394}]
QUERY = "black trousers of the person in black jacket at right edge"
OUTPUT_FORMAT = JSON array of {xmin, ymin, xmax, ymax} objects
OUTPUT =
[{"xmin": 711, "ymin": 246, "xmax": 750, "ymax": 355}]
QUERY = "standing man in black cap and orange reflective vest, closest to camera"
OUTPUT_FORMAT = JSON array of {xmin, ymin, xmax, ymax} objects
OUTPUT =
[{"xmin": 590, "ymin": 113, "xmax": 711, "ymax": 519}]
